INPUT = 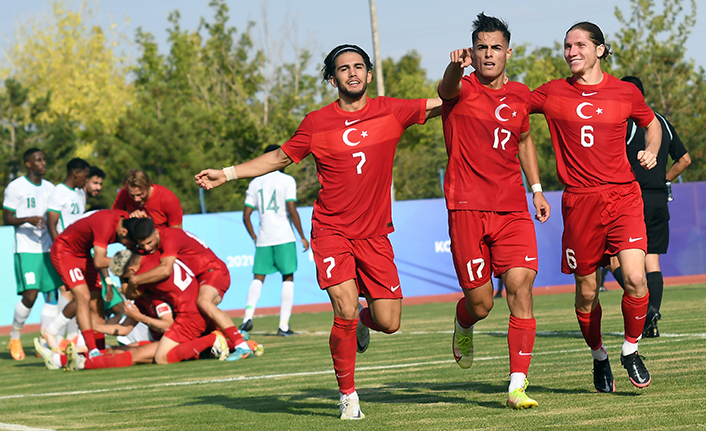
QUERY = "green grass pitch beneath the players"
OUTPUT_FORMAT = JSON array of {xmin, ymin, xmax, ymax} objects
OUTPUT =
[{"xmin": 0, "ymin": 285, "xmax": 706, "ymax": 431}]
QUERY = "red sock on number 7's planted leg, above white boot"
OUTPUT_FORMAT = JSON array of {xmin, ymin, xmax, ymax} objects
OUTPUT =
[{"xmin": 328, "ymin": 316, "xmax": 358, "ymax": 395}]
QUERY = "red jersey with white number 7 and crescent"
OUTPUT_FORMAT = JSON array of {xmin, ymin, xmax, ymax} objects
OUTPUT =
[{"xmin": 282, "ymin": 97, "xmax": 426, "ymax": 239}]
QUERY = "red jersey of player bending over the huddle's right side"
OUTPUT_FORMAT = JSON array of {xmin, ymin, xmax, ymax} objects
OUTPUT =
[{"xmin": 159, "ymin": 227, "xmax": 223, "ymax": 277}]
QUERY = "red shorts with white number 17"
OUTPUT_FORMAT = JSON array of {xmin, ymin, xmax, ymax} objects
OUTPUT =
[{"xmin": 449, "ymin": 210, "xmax": 538, "ymax": 289}]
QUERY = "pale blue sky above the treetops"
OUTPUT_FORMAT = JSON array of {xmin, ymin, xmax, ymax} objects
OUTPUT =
[{"xmin": 0, "ymin": 0, "xmax": 706, "ymax": 78}]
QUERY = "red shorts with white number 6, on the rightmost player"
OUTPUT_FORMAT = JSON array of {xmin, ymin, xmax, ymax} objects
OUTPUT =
[{"xmin": 561, "ymin": 181, "xmax": 647, "ymax": 276}]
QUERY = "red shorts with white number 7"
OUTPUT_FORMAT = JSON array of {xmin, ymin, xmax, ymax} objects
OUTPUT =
[{"xmin": 311, "ymin": 235, "xmax": 402, "ymax": 299}]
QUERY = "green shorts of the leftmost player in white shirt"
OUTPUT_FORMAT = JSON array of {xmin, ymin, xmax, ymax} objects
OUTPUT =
[{"xmin": 15, "ymin": 253, "xmax": 62, "ymax": 295}]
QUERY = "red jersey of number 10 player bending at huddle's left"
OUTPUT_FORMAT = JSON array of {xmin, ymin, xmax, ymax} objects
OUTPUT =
[{"xmin": 54, "ymin": 210, "xmax": 130, "ymax": 258}]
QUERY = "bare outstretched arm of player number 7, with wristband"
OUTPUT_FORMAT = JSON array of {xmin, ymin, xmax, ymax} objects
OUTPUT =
[{"xmin": 194, "ymin": 148, "xmax": 292, "ymax": 190}]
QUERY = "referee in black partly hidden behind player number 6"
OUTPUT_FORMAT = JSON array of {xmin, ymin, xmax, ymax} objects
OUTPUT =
[{"xmin": 610, "ymin": 76, "xmax": 691, "ymax": 338}]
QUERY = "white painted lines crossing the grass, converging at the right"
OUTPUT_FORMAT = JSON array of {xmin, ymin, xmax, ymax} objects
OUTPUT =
[{"xmin": 0, "ymin": 331, "xmax": 706, "ymax": 402}]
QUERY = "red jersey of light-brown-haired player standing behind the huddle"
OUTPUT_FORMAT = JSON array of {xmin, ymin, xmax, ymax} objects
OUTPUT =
[{"xmin": 113, "ymin": 184, "xmax": 184, "ymax": 227}]
